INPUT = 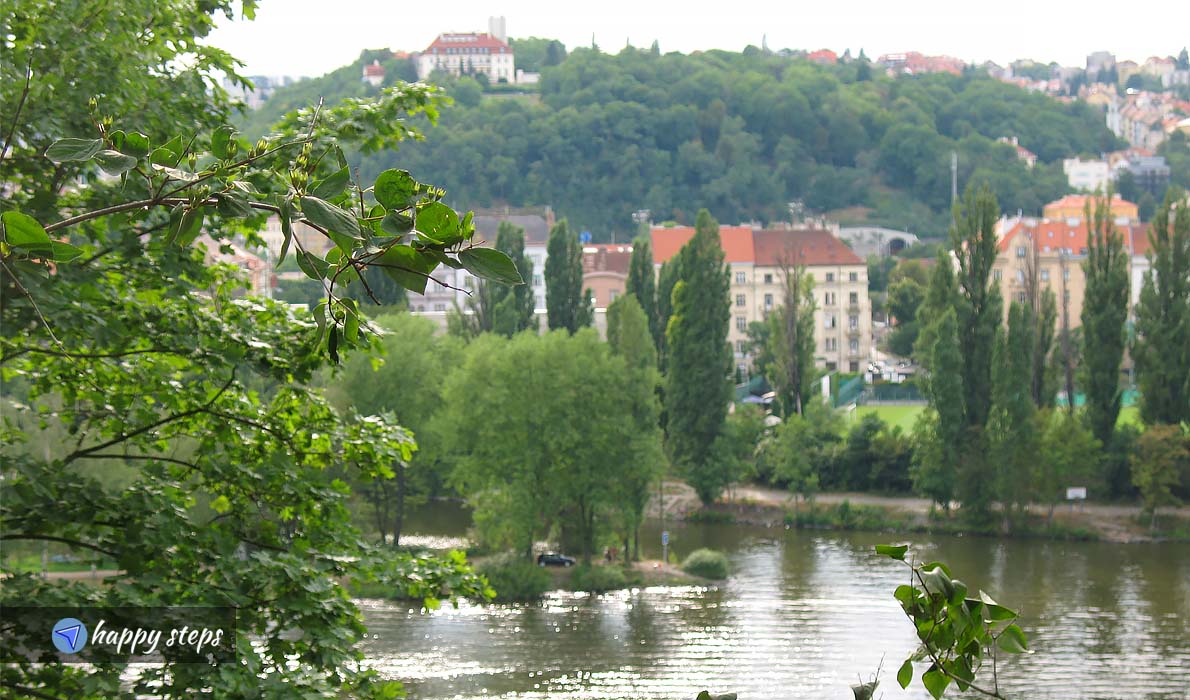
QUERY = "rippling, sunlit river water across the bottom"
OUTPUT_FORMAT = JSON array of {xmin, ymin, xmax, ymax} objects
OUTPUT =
[{"xmin": 359, "ymin": 506, "xmax": 1190, "ymax": 700}]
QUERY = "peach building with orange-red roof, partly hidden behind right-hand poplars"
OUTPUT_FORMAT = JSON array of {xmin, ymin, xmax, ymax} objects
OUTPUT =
[{"xmin": 991, "ymin": 219, "xmax": 1148, "ymax": 327}]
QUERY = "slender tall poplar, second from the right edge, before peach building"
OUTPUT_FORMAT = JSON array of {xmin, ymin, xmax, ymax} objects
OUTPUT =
[{"xmin": 1083, "ymin": 189, "xmax": 1128, "ymax": 449}]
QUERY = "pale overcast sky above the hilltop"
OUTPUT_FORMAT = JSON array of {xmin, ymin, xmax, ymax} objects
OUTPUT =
[{"xmin": 208, "ymin": 0, "xmax": 1190, "ymax": 75}]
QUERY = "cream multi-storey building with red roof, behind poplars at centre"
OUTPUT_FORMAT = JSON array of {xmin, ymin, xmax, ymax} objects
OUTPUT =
[{"xmin": 651, "ymin": 226, "xmax": 872, "ymax": 371}]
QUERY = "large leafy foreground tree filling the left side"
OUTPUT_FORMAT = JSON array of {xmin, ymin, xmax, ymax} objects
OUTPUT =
[{"xmin": 0, "ymin": 0, "xmax": 502, "ymax": 698}]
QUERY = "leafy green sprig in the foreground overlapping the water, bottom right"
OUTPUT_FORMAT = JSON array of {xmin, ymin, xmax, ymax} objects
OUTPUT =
[{"xmin": 876, "ymin": 545, "xmax": 1029, "ymax": 699}]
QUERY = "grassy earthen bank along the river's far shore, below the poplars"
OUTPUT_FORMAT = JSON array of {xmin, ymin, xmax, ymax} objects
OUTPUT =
[{"xmin": 649, "ymin": 481, "xmax": 1190, "ymax": 543}]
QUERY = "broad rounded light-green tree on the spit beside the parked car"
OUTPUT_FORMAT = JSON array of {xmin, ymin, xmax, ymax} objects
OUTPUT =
[{"xmin": 445, "ymin": 330, "xmax": 659, "ymax": 558}]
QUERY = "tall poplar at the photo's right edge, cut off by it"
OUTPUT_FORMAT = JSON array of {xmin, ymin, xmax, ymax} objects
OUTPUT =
[{"xmin": 1133, "ymin": 190, "xmax": 1190, "ymax": 425}]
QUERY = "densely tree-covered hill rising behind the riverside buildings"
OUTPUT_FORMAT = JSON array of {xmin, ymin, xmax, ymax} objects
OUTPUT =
[{"xmin": 241, "ymin": 48, "xmax": 1121, "ymax": 239}]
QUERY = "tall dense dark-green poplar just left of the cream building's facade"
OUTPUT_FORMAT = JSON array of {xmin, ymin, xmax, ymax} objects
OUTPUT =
[{"xmin": 665, "ymin": 210, "xmax": 732, "ymax": 504}]
